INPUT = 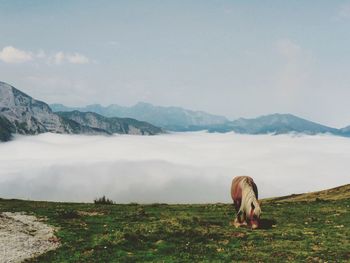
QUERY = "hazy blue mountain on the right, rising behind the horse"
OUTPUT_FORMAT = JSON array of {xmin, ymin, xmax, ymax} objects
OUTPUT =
[{"xmin": 209, "ymin": 113, "xmax": 341, "ymax": 135}]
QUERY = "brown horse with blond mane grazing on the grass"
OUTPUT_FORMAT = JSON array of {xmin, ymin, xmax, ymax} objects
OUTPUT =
[{"xmin": 231, "ymin": 176, "xmax": 261, "ymax": 229}]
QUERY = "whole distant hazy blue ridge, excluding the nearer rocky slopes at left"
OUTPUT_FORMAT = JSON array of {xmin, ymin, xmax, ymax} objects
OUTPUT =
[{"xmin": 51, "ymin": 102, "xmax": 350, "ymax": 136}]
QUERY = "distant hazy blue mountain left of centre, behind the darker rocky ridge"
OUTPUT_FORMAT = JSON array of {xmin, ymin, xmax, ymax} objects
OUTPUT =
[{"xmin": 51, "ymin": 102, "xmax": 228, "ymax": 131}]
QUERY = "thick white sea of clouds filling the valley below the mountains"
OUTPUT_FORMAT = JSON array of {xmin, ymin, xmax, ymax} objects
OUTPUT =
[{"xmin": 0, "ymin": 132, "xmax": 350, "ymax": 203}]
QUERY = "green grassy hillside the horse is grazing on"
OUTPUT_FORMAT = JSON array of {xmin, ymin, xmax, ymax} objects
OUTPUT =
[{"xmin": 0, "ymin": 185, "xmax": 350, "ymax": 262}]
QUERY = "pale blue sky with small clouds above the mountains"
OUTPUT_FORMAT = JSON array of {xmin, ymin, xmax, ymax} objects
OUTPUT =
[{"xmin": 0, "ymin": 0, "xmax": 350, "ymax": 127}]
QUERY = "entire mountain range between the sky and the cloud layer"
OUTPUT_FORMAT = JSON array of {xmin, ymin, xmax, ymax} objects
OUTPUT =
[{"xmin": 0, "ymin": 82, "xmax": 350, "ymax": 141}]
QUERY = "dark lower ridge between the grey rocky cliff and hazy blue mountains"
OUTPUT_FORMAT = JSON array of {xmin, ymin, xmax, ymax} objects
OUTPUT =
[{"xmin": 57, "ymin": 111, "xmax": 163, "ymax": 135}]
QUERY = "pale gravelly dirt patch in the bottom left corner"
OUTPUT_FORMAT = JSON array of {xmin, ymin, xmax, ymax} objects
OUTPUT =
[{"xmin": 0, "ymin": 212, "xmax": 59, "ymax": 263}]
